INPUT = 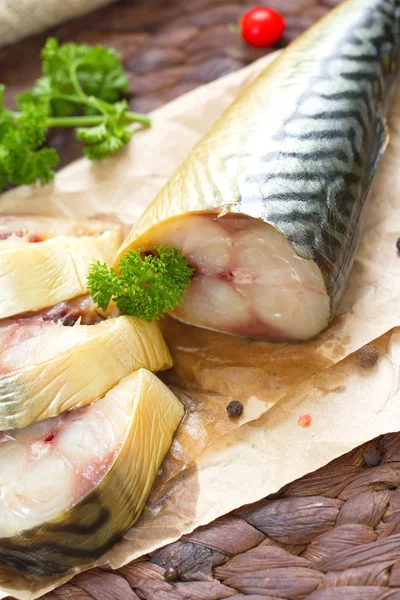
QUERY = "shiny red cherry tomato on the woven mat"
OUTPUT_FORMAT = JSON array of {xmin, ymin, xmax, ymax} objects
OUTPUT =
[{"xmin": 240, "ymin": 6, "xmax": 285, "ymax": 48}]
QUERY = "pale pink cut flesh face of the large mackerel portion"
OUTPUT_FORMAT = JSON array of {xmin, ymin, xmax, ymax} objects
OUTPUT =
[{"xmin": 119, "ymin": 212, "xmax": 331, "ymax": 341}]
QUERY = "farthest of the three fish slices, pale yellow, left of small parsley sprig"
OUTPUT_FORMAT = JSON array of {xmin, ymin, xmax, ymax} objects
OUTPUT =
[{"xmin": 0, "ymin": 217, "xmax": 121, "ymax": 319}]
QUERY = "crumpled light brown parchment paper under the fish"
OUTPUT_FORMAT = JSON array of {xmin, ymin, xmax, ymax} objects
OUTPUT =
[{"xmin": 0, "ymin": 50, "xmax": 400, "ymax": 600}]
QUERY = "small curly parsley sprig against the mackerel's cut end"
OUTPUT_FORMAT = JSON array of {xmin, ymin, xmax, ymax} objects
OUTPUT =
[{"xmin": 88, "ymin": 245, "xmax": 193, "ymax": 321}]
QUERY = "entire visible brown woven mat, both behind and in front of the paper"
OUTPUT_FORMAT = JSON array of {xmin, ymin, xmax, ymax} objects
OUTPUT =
[{"xmin": 4, "ymin": 0, "xmax": 400, "ymax": 600}]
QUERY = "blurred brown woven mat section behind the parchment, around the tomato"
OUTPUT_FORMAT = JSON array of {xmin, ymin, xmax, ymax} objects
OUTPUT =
[{"xmin": 0, "ymin": 0, "xmax": 340, "ymax": 167}]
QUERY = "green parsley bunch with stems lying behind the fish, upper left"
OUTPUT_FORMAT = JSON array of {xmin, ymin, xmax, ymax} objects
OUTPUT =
[{"xmin": 0, "ymin": 38, "xmax": 150, "ymax": 189}]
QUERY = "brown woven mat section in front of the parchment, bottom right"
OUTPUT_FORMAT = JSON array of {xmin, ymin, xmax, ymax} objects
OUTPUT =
[{"xmin": 44, "ymin": 433, "xmax": 400, "ymax": 600}]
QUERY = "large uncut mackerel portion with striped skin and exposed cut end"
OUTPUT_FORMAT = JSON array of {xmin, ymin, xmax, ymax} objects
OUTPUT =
[{"xmin": 115, "ymin": 0, "xmax": 400, "ymax": 341}]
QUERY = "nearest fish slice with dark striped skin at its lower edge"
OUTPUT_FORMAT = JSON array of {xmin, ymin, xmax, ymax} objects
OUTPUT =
[{"xmin": 0, "ymin": 369, "xmax": 184, "ymax": 576}]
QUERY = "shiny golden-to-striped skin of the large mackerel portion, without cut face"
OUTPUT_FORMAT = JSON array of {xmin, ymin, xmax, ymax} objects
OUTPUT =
[{"xmin": 118, "ymin": 0, "xmax": 400, "ymax": 340}]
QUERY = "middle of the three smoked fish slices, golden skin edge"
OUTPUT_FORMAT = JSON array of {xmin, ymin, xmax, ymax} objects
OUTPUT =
[{"xmin": 0, "ymin": 316, "xmax": 172, "ymax": 431}]
